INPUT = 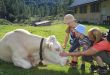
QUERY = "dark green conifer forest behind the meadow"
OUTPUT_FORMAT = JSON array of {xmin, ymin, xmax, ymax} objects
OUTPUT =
[{"xmin": 0, "ymin": 0, "xmax": 73, "ymax": 22}]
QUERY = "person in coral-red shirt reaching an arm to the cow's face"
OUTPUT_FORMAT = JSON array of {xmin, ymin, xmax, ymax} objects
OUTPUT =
[{"xmin": 60, "ymin": 30, "xmax": 110, "ymax": 74}]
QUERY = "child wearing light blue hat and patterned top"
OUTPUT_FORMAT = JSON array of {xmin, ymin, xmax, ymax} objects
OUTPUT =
[{"xmin": 75, "ymin": 25, "xmax": 94, "ymax": 71}]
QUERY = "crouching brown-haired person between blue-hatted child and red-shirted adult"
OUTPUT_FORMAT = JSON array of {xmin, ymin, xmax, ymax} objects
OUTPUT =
[{"xmin": 88, "ymin": 27, "xmax": 107, "ymax": 73}]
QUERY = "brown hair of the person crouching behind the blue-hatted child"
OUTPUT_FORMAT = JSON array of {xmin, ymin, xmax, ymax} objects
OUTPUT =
[{"xmin": 88, "ymin": 28, "xmax": 102, "ymax": 44}]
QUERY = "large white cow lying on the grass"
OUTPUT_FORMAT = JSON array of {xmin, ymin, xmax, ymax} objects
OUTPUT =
[{"xmin": 0, "ymin": 29, "xmax": 67, "ymax": 69}]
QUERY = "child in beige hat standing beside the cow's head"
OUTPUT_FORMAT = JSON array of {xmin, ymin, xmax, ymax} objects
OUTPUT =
[{"xmin": 63, "ymin": 14, "xmax": 81, "ymax": 67}]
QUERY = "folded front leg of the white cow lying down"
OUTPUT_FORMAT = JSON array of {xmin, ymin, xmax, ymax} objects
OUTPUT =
[{"xmin": 11, "ymin": 44, "xmax": 32, "ymax": 69}]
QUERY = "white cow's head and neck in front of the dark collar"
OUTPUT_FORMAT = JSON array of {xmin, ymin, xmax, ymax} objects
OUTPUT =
[{"xmin": 43, "ymin": 35, "xmax": 67, "ymax": 66}]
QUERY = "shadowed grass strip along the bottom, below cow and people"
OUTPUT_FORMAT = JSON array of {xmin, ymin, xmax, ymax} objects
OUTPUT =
[{"xmin": 0, "ymin": 62, "xmax": 110, "ymax": 75}]
